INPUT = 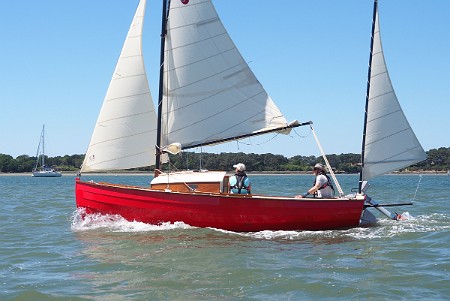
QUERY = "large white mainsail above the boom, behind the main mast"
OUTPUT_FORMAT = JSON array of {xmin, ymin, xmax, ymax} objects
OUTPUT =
[{"xmin": 162, "ymin": 0, "xmax": 287, "ymax": 147}]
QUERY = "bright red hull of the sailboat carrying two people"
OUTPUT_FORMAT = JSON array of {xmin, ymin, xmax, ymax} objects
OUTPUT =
[{"xmin": 75, "ymin": 179, "xmax": 364, "ymax": 232}]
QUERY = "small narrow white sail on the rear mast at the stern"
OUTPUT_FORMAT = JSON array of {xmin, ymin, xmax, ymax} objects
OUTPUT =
[{"xmin": 363, "ymin": 12, "xmax": 426, "ymax": 180}]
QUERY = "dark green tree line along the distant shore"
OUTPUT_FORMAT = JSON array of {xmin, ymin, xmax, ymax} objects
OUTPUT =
[{"xmin": 0, "ymin": 147, "xmax": 450, "ymax": 173}]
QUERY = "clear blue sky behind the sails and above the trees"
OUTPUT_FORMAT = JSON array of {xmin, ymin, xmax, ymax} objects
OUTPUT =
[{"xmin": 0, "ymin": 0, "xmax": 450, "ymax": 157}]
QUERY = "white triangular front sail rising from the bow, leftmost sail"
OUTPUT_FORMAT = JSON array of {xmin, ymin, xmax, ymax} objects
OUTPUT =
[{"xmin": 81, "ymin": 0, "xmax": 156, "ymax": 172}]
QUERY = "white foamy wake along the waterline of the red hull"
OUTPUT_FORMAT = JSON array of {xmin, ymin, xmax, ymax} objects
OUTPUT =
[{"xmin": 71, "ymin": 208, "xmax": 450, "ymax": 243}]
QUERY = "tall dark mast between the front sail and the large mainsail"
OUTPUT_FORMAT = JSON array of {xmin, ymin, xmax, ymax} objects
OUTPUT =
[{"xmin": 155, "ymin": 0, "xmax": 169, "ymax": 169}]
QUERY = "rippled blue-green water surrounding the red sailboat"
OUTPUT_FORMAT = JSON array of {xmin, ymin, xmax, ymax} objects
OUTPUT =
[{"xmin": 0, "ymin": 175, "xmax": 450, "ymax": 300}]
